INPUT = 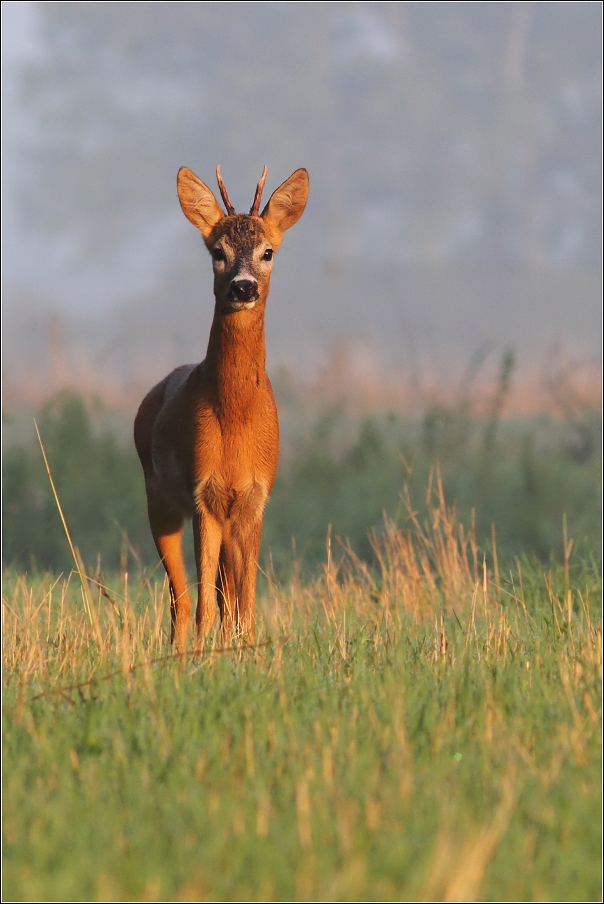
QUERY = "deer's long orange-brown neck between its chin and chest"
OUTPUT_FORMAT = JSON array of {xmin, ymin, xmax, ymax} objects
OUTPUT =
[{"xmin": 205, "ymin": 304, "xmax": 266, "ymax": 414}]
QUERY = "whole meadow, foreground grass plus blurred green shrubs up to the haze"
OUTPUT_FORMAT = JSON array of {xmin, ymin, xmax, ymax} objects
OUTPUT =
[{"xmin": 3, "ymin": 356, "xmax": 602, "ymax": 901}]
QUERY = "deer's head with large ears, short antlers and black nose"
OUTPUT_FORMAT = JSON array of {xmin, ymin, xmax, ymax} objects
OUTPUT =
[{"xmin": 177, "ymin": 166, "xmax": 308, "ymax": 314}]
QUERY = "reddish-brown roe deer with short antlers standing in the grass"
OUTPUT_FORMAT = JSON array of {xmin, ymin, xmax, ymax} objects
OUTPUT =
[{"xmin": 134, "ymin": 166, "xmax": 309, "ymax": 651}]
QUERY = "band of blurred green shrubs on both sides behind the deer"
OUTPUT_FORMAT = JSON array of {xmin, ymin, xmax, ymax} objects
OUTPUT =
[{"xmin": 2, "ymin": 370, "xmax": 601, "ymax": 576}]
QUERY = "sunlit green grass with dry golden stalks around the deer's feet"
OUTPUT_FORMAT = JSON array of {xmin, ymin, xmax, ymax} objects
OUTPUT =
[{"xmin": 3, "ymin": 488, "xmax": 602, "ymax": 901}]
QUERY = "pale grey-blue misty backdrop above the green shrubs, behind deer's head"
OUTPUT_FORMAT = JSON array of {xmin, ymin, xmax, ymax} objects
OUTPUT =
[{"xmin": 2, "ymin": 0, "xmax": 601, "ymax": 408}]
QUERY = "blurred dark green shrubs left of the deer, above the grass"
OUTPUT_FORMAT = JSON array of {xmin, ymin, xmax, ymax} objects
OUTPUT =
[{"xmin": 2, "ymin": 393, "xmax": 149, "ymax": 572}]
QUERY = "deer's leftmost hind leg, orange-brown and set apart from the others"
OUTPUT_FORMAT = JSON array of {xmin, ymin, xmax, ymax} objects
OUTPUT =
[{"xmin": 147, "ymin": 488, "xmax": 191, "ymax": 650}]
